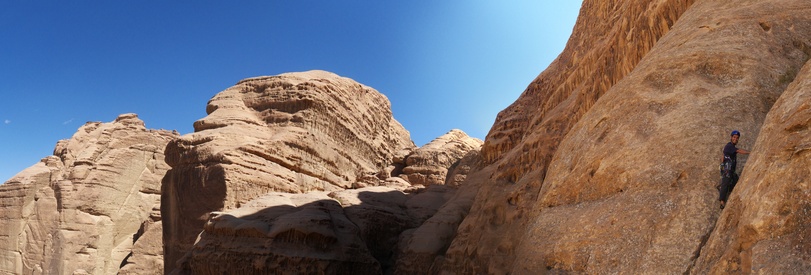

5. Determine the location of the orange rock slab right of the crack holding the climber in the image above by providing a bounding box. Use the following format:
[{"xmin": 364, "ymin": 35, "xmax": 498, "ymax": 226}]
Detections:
[{"xmin": 692, "ymin": 44, "xmax": 811, "ymax": 274}]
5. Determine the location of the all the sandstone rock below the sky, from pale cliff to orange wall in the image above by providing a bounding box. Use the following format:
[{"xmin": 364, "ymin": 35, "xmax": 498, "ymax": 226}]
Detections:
[{"xmin": 0, "ymin": 0, "xmax": 811, "ymax": 274}]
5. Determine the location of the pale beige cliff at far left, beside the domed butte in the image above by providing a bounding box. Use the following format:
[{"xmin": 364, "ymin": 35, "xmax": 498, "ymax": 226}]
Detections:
[{"xmin": 0, "ymin": 114, "xmax": 177, "ymax": 274}]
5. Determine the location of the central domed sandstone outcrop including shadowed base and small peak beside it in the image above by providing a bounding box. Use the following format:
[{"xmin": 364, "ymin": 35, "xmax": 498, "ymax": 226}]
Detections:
[{"xmin": 161, "ymin": 71, "xmax": 481, "ymax": 274}]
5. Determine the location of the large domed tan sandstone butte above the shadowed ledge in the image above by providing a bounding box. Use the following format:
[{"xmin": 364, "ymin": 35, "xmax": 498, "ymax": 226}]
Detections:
[{"xmin": 161, "ymin": 71, "xmax": 426, "ymax": 271}]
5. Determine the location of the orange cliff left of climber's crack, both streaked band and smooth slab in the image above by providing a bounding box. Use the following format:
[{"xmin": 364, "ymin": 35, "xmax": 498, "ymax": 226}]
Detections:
[{"xmin": 434, "ymin": 1, "xmax": 811, "ymax": 274}]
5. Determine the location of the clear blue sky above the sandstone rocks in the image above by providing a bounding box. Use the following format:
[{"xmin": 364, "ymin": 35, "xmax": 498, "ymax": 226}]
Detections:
[{"xmin": 0, "ymin": 0, "xmax": 581, "ymax": 182}]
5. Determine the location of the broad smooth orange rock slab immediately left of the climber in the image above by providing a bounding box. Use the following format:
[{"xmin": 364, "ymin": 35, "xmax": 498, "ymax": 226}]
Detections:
[{"xmin": 502, "ymin": 1, "xmax": 811, "ymax": 274}]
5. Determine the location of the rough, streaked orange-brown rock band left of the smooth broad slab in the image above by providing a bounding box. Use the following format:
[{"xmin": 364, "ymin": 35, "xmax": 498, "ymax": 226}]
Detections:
[{"xmin": 441, "ymin": 0, "xmax": 693, "ymax": 273}]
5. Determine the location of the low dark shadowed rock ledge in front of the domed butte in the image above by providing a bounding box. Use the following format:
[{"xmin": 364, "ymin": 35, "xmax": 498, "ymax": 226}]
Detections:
[{"xmin": 185, "ymin": 185, "xmax": 460, "ymax": 274}]
